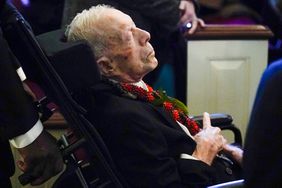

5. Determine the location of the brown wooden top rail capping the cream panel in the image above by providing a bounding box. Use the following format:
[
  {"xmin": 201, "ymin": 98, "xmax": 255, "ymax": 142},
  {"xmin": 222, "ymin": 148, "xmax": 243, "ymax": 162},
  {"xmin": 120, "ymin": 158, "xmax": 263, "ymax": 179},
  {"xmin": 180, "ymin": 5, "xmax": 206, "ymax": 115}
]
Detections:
[{"xmin": 184, "ymin": 24, "xmax": 273, "ymax": 40}]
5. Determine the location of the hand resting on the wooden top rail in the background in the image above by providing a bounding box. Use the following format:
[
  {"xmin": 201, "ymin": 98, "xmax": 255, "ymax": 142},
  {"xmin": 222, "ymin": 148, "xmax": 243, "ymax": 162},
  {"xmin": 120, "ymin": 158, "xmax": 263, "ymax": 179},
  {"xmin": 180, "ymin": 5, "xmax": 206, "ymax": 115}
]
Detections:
[{"xmin": 179, "ymin": 0, "xmax": 205, "ymax": 34}]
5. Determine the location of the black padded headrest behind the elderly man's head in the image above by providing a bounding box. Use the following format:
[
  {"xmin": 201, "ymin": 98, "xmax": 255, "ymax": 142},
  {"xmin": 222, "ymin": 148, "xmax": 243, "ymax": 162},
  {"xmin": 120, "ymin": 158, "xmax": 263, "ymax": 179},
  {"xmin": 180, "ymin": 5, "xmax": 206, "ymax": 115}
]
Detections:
[{"xmin": 36, "ymin": 29, "xmax": 100, "ymax": 92}]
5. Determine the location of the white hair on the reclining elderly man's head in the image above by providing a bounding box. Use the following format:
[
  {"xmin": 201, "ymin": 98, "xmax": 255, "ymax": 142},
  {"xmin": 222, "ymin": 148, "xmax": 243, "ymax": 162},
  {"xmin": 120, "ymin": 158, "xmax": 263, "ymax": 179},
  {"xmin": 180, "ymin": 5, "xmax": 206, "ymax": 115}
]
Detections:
[{"xmin": 65, "ymin": 5, "xmax": 114, "ymax": 59}]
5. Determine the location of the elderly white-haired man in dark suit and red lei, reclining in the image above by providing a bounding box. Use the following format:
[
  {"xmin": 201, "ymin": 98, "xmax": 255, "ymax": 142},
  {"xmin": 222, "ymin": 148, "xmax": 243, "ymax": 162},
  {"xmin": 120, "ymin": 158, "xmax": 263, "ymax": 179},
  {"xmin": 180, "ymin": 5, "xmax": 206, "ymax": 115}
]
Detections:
[{"xmin": 0, "ymin": 1, "xmax": 248, "ymax": 187}]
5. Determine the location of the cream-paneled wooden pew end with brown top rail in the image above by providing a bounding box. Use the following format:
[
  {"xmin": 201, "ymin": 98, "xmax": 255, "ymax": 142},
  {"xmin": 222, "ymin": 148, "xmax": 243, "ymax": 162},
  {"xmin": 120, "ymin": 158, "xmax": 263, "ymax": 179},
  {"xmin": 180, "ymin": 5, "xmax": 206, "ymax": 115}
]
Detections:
[{"xmin": 185, "ymin": 25, "xmax": 273, "ymax": 142}]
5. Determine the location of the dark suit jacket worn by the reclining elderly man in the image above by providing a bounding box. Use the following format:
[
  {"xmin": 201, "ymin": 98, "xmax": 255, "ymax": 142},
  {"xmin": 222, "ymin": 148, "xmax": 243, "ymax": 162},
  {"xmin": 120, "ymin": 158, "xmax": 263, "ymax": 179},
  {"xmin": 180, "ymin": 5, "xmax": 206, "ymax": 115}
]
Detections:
[{"xmin": 84, "ymin": 83, "xmax": 240, "ymax": 187}]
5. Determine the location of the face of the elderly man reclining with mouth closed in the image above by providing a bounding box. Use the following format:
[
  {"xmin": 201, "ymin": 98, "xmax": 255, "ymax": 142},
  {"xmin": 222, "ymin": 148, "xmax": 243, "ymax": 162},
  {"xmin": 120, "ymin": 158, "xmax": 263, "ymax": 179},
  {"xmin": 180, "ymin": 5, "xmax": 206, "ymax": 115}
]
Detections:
[{"xmin": 99, "ymin": 10, "xmax": 158, "ymax": 82}]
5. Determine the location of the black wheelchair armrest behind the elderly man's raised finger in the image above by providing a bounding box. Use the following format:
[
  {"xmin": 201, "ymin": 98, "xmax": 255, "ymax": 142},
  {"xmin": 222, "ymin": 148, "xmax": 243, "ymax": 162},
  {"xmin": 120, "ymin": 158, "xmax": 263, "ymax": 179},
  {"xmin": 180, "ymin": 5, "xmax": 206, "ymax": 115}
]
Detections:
[{"xmin": 190, "ymin": 113, "xmax": 242, "ymax": 146}]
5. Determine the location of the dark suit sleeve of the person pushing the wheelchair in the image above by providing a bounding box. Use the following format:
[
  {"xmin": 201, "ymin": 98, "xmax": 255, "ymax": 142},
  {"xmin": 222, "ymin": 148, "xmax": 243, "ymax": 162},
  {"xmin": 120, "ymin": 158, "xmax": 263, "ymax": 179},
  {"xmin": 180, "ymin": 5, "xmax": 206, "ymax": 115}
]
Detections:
[{"xmin": 0, "ymin": 28, "xmax": 38, "ymax": 181}]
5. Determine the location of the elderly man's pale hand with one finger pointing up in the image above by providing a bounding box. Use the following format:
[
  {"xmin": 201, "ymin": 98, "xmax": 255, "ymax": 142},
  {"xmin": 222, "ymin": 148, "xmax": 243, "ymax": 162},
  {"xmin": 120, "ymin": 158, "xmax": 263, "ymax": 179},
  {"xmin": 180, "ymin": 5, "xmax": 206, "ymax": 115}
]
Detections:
[{"xmin": 192, "ymin": 112, "xmax": 226, "ymax": 165}]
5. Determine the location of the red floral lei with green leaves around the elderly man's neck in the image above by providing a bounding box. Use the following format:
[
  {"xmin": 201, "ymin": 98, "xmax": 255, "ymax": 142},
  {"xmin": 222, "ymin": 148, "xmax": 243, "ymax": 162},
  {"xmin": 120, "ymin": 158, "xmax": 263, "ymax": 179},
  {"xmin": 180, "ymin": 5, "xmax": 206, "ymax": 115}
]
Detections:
[{"xmin": 120, "ymin": 83, "xmax": 200, "ymax": 135}]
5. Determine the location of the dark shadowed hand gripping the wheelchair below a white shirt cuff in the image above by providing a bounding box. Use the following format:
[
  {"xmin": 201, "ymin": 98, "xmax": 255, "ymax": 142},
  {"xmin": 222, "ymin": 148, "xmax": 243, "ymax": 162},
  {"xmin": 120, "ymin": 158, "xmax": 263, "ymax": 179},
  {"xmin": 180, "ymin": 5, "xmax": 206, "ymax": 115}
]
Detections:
[{"xmin": 17, "ymin": 130, "xmax": 63, "ymax": 185}]
